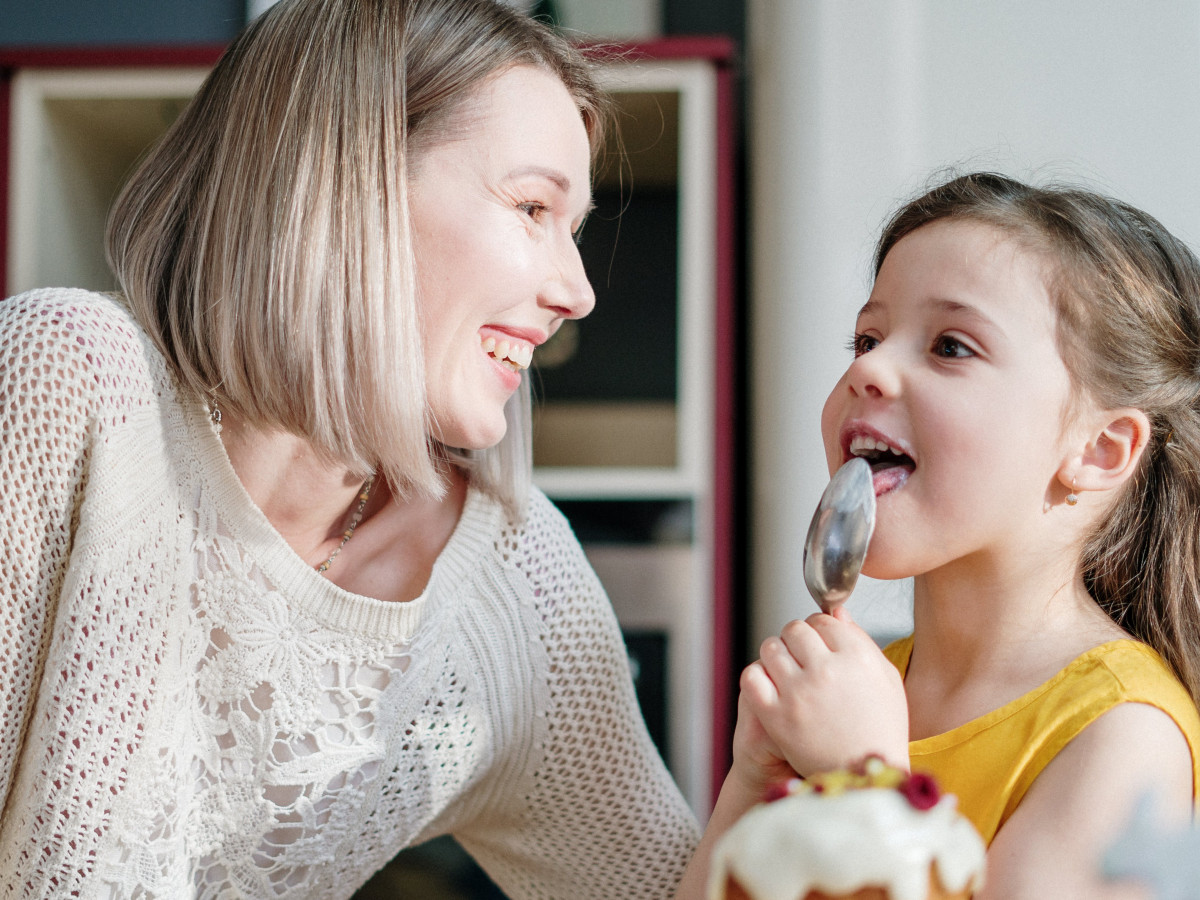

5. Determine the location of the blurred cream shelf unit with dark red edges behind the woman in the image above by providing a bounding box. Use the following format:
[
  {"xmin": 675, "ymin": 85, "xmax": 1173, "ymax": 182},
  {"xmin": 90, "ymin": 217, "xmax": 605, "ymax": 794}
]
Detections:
[{"xmin": 0, "ymin": 37, "xmax": 737, "ymax": 816}]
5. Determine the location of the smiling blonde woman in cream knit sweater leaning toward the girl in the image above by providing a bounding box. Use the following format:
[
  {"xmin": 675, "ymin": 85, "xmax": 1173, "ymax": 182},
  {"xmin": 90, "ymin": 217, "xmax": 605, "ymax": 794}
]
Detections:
[{"xmin": 0, "ymin": 0, "xmax": 698, "ymax": 898}]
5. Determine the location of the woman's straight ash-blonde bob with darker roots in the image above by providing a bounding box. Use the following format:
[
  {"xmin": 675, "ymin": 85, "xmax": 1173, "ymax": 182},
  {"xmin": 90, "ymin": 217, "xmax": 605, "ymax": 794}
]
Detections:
[{"xmin": 107, "ymin": 0, "xmax": 607, "ymax": 506}]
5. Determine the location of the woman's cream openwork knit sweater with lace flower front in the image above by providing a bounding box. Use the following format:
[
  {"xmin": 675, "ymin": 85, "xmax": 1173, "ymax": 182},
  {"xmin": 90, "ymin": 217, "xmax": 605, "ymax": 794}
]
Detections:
[{"xmin": 0, "ymin": 289, "xmax": 697, "ymax": 900}]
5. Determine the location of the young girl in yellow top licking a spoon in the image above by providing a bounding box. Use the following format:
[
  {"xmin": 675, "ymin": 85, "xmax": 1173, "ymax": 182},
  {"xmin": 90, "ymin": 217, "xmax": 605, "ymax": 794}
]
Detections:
[{"xmin": 743, "ymin": 174, "xmax": 1200, "ymax": 898}]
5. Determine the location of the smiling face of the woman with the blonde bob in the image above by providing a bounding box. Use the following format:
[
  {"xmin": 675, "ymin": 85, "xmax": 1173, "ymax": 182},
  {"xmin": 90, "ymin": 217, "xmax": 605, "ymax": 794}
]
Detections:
[{"xmin": 410, "ymin": 66, "xmax": 595, "ymax": 450}]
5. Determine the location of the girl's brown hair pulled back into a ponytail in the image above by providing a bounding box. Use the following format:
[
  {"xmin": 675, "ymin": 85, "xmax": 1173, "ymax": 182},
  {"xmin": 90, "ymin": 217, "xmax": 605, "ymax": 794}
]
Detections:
[{"xmin": 875, "ymin": 173, "xmax": 1200, "ymax": 703}]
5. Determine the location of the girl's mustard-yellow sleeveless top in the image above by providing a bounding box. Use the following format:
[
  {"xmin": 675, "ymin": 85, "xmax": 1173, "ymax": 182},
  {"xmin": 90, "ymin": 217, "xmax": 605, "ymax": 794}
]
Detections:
[{"xmin": 883, "ymin": 636, "xmax": 1200, "ymax": 844}]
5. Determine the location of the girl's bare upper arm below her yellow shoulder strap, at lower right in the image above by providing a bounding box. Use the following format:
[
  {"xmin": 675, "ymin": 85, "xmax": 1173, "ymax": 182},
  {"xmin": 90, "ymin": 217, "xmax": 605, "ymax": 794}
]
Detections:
[{"xmin": 977, "ymin": 703, "xmax": 1193, "ymax": 900}]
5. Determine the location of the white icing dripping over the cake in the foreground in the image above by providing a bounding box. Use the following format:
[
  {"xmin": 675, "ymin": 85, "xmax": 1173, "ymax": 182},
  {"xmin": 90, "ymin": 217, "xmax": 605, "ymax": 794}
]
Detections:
[{"xmin": 708, "ymin": 788, "xmax": 986, "ymax": 900}]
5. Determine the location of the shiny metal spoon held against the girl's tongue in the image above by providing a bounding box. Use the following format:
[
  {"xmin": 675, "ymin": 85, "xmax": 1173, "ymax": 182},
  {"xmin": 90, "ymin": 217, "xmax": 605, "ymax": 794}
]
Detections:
[{"xmin": 804, "ymin": 458, "xmax": 875, "ymax": 612}]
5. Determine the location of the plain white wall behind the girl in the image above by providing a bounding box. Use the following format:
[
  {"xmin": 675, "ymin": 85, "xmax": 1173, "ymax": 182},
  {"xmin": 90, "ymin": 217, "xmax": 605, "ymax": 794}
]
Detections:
[{"xmin": 746, "ymin": 0, "xmax": 1200, "ymax": 646}]
